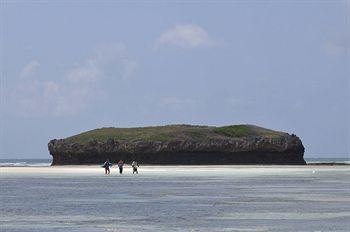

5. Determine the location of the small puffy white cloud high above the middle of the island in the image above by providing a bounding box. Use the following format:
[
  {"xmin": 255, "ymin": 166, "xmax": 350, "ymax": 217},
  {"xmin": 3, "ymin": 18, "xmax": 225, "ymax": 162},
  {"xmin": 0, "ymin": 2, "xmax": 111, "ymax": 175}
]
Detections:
[{"xmin": 155, "ymin": 24, "xmax": 217, "ymax": 48}]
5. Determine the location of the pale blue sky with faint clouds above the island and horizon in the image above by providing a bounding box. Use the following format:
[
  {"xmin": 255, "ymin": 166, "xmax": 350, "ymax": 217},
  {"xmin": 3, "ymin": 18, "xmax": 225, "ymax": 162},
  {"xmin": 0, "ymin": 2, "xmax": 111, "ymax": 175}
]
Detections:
[{"xmin": 0, "ymin": 0, "xmax": 350, "ymax": 158}]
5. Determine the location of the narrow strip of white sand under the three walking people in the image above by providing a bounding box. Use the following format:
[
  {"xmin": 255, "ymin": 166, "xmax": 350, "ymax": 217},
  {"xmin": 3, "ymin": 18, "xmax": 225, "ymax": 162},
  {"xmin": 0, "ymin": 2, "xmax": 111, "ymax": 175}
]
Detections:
[{"xmin": 0, "ymin": 165, "xmax": 350, "ymax": 177}]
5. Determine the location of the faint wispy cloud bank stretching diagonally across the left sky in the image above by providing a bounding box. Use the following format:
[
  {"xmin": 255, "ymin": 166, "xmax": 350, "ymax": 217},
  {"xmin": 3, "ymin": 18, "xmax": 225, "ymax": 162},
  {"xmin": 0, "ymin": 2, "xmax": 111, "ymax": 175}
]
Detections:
[{"xmin": 13, "ymin": 44, "xmax": 136, "ymax": 116}]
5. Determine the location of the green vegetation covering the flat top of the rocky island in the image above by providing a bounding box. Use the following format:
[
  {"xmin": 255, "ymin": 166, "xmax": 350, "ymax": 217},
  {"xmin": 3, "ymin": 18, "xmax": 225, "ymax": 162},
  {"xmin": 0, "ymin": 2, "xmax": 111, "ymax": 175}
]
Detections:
[{"xmin": 65, "ymin": 125, "xmax": 285, "ymax": 144}]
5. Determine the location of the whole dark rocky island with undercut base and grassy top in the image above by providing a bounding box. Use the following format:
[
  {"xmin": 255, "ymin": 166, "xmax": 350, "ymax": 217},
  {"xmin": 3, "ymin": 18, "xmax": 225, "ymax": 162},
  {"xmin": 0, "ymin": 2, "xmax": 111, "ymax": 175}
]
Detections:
[{"xmin": 48, "ymin": 125, "xmax": 306, "ymax": 165}]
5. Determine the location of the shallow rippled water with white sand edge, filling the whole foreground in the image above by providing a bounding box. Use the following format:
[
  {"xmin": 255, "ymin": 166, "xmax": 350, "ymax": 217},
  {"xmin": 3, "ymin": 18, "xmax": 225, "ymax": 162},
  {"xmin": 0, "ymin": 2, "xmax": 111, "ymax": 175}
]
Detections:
[{"xmin": 0, "ymin": 166, "xmax": 350, "ymax": 232}]
